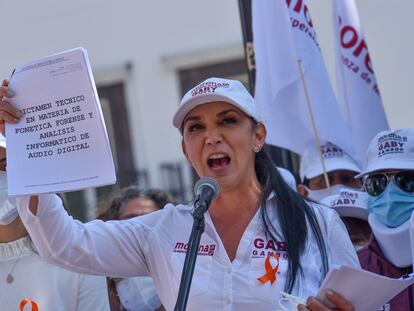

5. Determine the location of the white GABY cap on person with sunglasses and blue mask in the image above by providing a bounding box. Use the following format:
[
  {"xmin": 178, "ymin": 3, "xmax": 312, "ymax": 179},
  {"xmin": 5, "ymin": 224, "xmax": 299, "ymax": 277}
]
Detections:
[{"xmin": 356, "ymin": 129, "xmax": 414, "ymax": 178}]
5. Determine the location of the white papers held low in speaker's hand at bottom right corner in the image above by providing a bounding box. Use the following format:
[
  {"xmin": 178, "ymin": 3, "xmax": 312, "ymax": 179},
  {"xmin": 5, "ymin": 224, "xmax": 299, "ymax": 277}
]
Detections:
[{"xmin": 316, "ymin": 266, "xmax": 414, "ymax": 311}]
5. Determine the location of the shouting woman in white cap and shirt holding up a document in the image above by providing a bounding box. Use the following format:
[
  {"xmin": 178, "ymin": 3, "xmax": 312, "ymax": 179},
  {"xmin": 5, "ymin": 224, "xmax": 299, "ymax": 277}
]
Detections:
[{"xmin": 0, "ymin": 78, "xmax": 359, "ymax": 311}]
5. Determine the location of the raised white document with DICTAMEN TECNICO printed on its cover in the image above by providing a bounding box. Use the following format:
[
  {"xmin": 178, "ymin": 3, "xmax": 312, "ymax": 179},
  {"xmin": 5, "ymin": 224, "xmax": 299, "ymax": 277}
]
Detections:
[{"xmin": 6, "ymin": 48, "xmax": 116, "ymax": 195}]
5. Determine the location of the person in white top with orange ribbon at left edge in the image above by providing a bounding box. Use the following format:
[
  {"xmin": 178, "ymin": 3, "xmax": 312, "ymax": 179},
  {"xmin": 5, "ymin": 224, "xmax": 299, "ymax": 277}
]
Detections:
[{"xmin": 0, "ymin": 133, "xmax": 109, "ymax": 311}]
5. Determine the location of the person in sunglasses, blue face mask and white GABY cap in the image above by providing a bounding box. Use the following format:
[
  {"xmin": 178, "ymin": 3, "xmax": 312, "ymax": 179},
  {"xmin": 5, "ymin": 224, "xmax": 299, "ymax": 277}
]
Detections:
[{"xmin": 357, "ymin": 129, "xmax": 414, "ymax": 311}]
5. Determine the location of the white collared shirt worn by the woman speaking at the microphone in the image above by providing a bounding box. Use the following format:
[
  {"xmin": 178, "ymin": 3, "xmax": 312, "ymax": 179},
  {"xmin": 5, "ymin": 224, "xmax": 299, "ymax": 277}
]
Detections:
[{"xmin": 18, "ymin": 195, "xmax": 359, "ymax": 311}]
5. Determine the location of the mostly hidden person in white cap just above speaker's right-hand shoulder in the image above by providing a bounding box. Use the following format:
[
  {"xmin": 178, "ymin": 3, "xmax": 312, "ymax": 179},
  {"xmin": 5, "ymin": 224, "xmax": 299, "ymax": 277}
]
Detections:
[{"xmin": 321, "ymin": 188, "xmax": 372, "ymax": 251}]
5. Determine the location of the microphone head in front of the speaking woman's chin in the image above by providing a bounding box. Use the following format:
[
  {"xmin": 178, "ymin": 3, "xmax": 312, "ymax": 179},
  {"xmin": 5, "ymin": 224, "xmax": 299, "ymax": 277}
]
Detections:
[{"xmin": 193, "ymin": 177, "xmax": 220, "ymax": 215}]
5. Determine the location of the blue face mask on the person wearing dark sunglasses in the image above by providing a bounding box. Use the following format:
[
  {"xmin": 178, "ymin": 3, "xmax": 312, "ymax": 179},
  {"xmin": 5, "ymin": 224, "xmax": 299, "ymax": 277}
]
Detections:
[{"xmin": 368, "ymin": 181, "xmax": 414, "ymax": 228}]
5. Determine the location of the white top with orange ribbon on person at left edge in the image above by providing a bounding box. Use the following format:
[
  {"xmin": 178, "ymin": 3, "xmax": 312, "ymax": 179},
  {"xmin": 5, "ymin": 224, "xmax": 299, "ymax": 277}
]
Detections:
[{"xmin": 0, "ymin": 236, "xmax": 109, "ymax": 311}]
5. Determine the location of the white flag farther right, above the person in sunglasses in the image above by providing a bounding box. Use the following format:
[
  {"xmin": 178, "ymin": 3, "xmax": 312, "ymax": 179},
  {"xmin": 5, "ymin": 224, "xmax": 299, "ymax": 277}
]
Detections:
[{"xmin": 333, "ymin": 0, "xmax": 389, "ymax": 167}]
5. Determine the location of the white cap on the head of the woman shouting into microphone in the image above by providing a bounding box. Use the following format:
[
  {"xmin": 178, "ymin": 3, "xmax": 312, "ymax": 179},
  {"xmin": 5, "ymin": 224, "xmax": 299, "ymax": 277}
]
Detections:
[{"xmin": 173, "ymin": 78, "xmax": 262, "ymax": 129}]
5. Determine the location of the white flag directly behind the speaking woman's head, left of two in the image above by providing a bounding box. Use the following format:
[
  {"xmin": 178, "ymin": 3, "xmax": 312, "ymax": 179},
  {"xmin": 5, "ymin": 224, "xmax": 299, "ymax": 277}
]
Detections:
[{"xmin": 252, "ymin": 0, "xmax": 358, "ymax": 166}]
